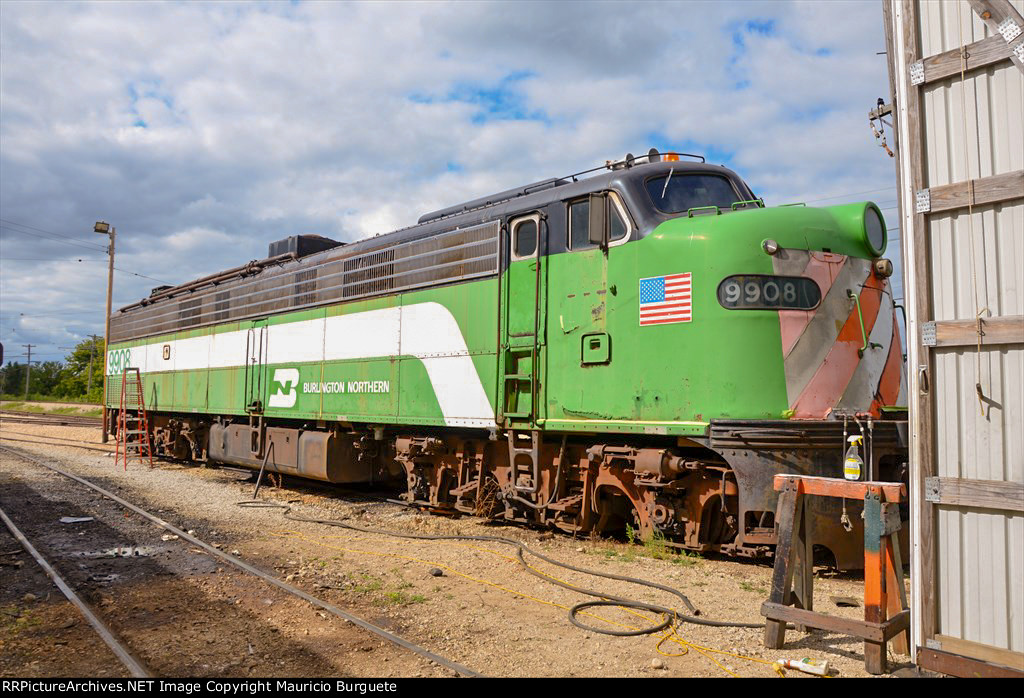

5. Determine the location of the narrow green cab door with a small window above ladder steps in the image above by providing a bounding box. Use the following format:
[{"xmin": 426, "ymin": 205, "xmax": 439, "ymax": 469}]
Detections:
[{"xmin": 499, "ymin": 212, "xmax": 547, "ymax": 429}]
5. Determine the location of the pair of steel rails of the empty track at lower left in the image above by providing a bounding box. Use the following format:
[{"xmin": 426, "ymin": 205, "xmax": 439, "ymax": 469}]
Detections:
[{"xmin": 0, "ymin": 445, "xmax": 480, "ymax": 677}]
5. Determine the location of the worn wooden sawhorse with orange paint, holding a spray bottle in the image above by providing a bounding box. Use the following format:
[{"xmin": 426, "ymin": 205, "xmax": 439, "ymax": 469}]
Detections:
[{"xmin": 761, "ymin": 475, "xmax": 910, "ymax": 674}]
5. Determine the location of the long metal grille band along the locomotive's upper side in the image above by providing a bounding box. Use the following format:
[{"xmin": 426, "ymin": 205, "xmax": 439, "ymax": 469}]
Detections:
[{"xmin": 111, "ymin": 215, "xmax": 501, "ymax": 343}]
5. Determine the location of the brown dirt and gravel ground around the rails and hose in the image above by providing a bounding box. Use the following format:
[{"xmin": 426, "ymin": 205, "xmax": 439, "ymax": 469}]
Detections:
[{"xmin": 0, "ymin": 424, "xmax": 909, "ymax": 678}]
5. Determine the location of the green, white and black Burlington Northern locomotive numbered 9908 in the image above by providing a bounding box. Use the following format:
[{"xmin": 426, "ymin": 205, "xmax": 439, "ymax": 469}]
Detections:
[{"xmin": 106, "ymin": 150, "xmax": 906, "ymax": 568}]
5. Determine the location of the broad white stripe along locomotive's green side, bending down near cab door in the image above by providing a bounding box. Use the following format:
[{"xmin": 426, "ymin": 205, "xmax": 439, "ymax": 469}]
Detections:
[{"xmin": 108, "ymin": 303, "xmax": 496, "ymax": 427}]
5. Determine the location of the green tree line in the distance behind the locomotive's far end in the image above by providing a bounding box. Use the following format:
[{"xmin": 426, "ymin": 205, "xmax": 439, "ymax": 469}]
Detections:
[{"xmin": 0, "ymin": 338, "xmax": 106, "ymax": 403}]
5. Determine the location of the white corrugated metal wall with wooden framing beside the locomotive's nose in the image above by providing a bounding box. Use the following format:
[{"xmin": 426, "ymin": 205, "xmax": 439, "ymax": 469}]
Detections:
[{"xmin": 884, "ymin": 0, "xmax": 1024, "ymax": 673}]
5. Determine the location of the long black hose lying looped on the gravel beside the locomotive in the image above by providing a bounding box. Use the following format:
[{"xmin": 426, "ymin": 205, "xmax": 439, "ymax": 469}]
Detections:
[{"xmin": 238, "ymin": 500, "xmax": 764, "ymax": 637}]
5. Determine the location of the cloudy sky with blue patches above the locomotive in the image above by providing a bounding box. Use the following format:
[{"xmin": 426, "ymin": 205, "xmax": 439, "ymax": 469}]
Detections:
[{"xmin": 0, "ymin": 0, "xmax": 902, "ymax": 361}]
